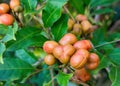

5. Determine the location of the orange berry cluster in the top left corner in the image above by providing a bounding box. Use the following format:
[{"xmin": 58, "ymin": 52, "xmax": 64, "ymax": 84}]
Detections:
[{"xmin": 0, "ymin": 0, "xmax": 22, "ymax": 26}]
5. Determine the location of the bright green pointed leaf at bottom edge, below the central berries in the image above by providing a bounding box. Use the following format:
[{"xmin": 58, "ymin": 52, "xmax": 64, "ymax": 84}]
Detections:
[{"xmin": 57, "ymin": 72, "xmax": 73, "ymax": 86}]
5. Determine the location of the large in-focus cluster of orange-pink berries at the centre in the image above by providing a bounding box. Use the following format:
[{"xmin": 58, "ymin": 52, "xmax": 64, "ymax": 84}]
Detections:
[{"xmin": 43, "ymin": 33, "xmax": 99, "ymax": 75}]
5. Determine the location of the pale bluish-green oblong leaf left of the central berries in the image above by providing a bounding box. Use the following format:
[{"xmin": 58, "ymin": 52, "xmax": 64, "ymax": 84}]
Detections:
[{"xmin": 15, "ymin": 49, "xmax": 37, "ymax": 65}]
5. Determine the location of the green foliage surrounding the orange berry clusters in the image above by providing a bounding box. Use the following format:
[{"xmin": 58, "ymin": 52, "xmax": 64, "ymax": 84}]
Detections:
[{"xmin": 0, "ymin": 0, "xmax": 120, "ymax": 86}]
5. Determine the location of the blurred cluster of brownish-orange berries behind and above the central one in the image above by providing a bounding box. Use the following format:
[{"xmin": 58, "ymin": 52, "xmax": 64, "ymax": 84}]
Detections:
[{"xmin": 68, "ymin": 14, "xmax": 94, "ymax": 35}]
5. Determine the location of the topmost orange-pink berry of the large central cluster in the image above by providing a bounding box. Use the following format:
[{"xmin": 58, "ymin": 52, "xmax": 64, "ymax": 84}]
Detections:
[{"xmin": 59, "ymin": 33, "xmax": 77, "ymax": 45}]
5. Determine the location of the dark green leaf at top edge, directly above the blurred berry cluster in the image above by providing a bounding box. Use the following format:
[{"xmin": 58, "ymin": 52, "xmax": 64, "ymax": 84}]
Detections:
[{"xmin": 69, "ymin": 0, "xmax": 86, "ymax": 14}]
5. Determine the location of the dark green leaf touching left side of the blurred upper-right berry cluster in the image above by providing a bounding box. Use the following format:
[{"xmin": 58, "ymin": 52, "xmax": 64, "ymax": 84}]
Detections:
[{"xmin": 51, "ymin": 15, "xmax": 68, "ymax": 41}]
